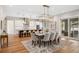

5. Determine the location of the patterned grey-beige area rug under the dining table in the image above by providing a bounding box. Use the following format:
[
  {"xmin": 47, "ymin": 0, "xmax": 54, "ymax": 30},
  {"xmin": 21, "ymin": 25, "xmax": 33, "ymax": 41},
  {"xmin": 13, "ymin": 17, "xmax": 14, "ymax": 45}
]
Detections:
[{"xmin": 21, "ymin": 39, "xmax": 59, "ymax": 53}]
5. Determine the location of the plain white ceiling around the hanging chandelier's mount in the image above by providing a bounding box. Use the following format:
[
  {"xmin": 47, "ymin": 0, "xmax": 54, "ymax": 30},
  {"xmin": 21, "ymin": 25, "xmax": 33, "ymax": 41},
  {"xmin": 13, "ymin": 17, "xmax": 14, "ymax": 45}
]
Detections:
[{"xmin": 4, "ymin": 5, "xmax": 79, "ymax": 17}]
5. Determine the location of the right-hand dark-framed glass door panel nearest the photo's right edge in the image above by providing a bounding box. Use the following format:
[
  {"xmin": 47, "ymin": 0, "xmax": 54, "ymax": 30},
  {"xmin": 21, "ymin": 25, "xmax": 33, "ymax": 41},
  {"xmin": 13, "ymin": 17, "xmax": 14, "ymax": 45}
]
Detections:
[{"xmin": 69, "ymin": 18, "xmax": 78, "ymax": 38}]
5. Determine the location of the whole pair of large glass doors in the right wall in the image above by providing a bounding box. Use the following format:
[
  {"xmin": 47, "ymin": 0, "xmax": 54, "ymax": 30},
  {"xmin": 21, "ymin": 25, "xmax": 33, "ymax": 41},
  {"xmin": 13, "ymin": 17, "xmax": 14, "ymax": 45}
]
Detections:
[{"xmin": 61, "ymin": 18, "xmax": 79, "ymax": 38}]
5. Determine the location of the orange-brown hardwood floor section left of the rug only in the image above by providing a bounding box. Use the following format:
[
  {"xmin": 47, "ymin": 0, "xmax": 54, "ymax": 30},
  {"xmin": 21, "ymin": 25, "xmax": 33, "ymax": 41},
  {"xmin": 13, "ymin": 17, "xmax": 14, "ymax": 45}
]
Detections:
[{"xmin": 0, "ymin": 36, "xmax": 30, "ymax": 53}]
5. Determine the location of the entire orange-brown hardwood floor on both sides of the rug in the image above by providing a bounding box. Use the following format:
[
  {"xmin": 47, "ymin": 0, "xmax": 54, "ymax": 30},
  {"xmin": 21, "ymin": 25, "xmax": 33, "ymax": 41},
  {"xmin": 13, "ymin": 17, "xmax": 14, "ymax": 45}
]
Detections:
[{"xmin": 0, "ymin": 36, "xmax": 79, "ymax": 53}]
